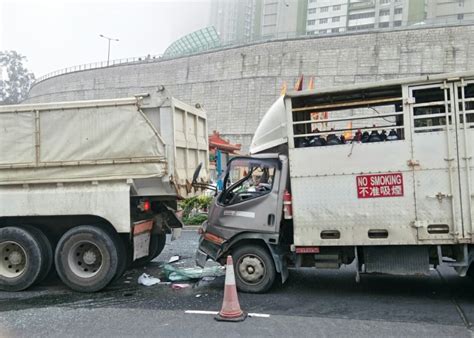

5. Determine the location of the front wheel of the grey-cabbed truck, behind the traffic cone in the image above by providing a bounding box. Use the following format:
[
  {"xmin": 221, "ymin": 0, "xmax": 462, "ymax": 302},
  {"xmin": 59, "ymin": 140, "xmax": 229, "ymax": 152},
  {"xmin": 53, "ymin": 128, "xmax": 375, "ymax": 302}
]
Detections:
[{"xmin": 232, "ymin": 245, "xmax": 276, "ymax": 293}]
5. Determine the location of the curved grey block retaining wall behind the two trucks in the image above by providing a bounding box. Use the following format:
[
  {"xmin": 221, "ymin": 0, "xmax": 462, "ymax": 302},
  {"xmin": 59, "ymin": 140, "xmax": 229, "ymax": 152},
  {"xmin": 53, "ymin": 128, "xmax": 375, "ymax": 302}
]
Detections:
[{"xmin": 28, "ymin": 25, "xmax": 474, "ymax": 150}]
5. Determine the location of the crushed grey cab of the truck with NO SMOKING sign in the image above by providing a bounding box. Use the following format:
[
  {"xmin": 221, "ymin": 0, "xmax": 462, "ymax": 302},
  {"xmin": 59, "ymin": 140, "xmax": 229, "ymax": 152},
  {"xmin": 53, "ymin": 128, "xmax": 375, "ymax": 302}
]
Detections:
[{"xmin": 197, "ymin": 154, "xmax": 288, "ymax": 292}]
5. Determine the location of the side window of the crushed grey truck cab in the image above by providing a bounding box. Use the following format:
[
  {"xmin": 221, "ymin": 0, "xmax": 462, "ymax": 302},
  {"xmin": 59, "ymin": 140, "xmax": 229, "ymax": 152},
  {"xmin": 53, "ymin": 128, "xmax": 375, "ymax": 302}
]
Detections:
[{"xmin": 218, "ymin": 158, "xmax": 276, "ymax": 205}]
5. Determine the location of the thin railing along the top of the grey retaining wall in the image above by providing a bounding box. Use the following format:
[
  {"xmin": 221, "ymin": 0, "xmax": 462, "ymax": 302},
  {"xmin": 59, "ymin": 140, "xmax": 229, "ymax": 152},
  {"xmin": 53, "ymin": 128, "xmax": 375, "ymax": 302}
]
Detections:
[{"xmin": 32, "ymin": 20, "xmax": 474, "ymax": 86}]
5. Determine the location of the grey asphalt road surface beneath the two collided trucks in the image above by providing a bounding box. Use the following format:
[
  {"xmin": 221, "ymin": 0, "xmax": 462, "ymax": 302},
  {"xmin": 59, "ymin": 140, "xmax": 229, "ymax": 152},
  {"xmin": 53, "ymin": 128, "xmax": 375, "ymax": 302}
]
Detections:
[{"xmin": 0, "ymin": 230, "xmax": 474, "ymax": 337}]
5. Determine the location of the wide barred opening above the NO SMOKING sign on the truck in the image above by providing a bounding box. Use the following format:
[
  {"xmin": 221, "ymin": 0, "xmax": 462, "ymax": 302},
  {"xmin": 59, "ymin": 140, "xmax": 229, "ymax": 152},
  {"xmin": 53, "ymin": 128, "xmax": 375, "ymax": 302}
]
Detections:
[{"xmin": 292, "ymin": 86, "xmax": 405, "ymax": 148}]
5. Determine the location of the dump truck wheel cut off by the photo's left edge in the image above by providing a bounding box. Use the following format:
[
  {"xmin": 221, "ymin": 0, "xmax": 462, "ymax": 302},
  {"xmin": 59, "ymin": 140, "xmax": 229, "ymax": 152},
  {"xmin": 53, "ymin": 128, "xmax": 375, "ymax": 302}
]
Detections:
[{"xmin": 0, "ymin": 227, "xmax": 44, "ymax": 291}]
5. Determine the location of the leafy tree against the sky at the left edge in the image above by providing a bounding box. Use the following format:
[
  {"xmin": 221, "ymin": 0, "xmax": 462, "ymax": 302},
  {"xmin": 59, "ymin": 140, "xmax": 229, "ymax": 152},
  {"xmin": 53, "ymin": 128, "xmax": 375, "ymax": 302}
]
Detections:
[{"xmin": 0, "ymin": 50, "xmax": 35, "ymax": 104}]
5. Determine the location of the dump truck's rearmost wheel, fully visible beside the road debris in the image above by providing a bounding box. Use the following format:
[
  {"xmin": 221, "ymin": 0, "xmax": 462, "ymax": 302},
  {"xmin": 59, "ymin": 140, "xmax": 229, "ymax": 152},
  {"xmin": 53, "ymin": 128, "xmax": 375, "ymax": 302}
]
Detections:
[{"xmin": 54, "ymin": 225, "xmax": 119, "ymax": 292}]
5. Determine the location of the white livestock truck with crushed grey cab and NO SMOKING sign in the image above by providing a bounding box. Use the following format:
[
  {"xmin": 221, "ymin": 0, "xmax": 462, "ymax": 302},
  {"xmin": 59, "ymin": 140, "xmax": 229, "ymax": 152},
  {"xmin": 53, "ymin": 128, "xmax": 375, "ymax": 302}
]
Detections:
[{"xmin": 197, "ymin": 73, "xmax": 474, "ymax": 292}]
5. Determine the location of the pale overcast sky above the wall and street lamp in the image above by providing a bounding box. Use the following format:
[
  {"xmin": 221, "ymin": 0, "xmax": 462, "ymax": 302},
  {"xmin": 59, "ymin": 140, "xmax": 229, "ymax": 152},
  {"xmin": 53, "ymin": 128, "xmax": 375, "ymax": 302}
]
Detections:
[{"xmin": 0, "ymin": 0, "xmax": 210, "ymax": 77}]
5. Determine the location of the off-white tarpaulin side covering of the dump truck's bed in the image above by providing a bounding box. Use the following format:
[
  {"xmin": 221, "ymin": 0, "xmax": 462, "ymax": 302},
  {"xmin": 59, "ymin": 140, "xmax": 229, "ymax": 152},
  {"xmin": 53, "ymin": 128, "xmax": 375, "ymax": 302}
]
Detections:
[{"xmin": 0, "ymin": 99, "xmax": 165, "ymax": 184}]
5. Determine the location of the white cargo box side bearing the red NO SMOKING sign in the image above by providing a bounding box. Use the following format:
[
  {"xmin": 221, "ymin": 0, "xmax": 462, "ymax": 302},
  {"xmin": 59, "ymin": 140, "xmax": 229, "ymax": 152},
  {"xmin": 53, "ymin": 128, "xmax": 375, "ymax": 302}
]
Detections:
[{"xmin": 285, "ymin": 74, "xmax": 474, "ymax": 246}]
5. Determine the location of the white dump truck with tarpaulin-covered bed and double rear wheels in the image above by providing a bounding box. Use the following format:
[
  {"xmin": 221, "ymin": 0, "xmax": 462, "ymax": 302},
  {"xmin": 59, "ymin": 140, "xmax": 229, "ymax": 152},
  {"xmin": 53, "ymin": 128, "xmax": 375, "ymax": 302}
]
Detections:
[{"xmin": 0, "ymin": 86, "xmax": 208, "ymax": 292}]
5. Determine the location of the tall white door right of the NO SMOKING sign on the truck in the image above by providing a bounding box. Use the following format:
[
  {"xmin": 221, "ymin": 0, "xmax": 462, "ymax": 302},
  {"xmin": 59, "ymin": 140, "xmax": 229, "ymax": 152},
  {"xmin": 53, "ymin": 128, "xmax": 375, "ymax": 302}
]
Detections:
[{"xmin": 408, "ymin": 81, "xmax": 470, "ymax": 242}]
